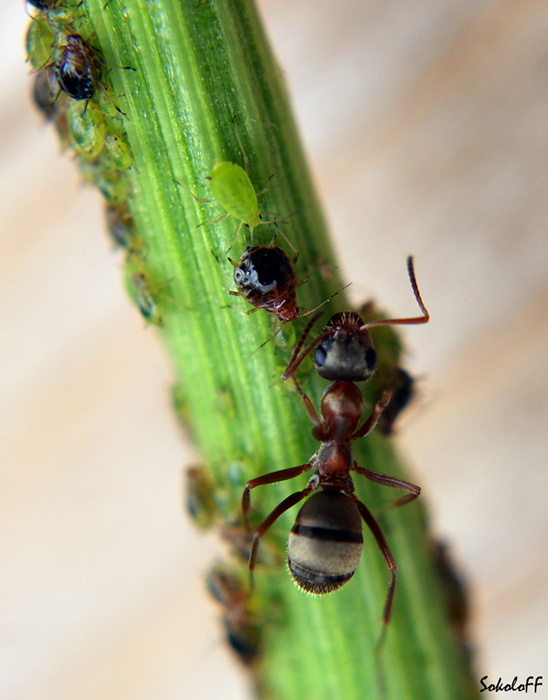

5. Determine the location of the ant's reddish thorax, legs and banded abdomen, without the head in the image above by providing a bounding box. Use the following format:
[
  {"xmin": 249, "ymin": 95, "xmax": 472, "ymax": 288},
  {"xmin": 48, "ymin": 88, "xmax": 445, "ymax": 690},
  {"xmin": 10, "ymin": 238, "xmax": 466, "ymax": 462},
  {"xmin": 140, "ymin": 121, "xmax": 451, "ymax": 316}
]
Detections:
[{"xmin": 242, "ymin": 381, "xmax": 420, "ymax": 625}]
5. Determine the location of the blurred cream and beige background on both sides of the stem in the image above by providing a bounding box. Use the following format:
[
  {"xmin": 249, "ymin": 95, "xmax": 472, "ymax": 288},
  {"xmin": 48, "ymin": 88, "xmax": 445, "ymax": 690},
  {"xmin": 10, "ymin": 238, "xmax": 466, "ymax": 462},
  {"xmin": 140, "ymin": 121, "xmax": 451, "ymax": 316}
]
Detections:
[{"xmin": 0, "ymin": 0, "xmax": 548, "ymax": 700}]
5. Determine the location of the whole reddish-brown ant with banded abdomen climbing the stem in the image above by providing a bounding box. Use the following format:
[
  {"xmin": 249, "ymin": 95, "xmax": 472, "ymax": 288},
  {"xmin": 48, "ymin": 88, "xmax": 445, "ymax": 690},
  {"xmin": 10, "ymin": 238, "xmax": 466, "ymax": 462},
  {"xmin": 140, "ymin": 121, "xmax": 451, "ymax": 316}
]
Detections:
[{"xmin": 242, "ymin": 258, "xmax": 429, "ymax": 639}]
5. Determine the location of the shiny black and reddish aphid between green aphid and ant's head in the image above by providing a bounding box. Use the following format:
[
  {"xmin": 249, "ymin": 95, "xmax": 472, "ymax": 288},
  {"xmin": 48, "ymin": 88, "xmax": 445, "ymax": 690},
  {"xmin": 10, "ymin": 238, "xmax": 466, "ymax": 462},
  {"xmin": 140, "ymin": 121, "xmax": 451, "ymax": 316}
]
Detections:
[{"xmin": 229, "ymin": 245, "xmax": 298, "ymax": 323}]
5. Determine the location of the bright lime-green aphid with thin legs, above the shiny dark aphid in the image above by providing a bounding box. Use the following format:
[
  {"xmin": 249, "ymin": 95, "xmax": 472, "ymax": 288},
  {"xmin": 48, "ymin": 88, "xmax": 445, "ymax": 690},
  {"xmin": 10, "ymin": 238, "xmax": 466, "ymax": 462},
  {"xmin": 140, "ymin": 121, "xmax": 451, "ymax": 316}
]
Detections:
[{"xmin": 181, "ymin": 119, "xmax": 295, "ymax": 253}]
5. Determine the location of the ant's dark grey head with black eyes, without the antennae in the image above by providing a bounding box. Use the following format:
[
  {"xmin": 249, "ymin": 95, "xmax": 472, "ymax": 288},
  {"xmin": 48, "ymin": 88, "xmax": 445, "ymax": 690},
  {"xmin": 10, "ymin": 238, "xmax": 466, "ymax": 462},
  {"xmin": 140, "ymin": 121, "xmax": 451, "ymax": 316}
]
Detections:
[{"xmin": 314, "ymin": 311, "xmax": 377, "ymax": 382}]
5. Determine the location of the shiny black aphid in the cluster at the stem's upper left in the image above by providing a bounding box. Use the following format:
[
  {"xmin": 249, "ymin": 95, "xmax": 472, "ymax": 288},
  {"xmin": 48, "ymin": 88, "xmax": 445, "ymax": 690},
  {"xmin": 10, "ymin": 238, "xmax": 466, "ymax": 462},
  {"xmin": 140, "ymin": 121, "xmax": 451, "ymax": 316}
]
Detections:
[{"xmin": 55, "ymin": 34, "xmax": 100, "ymax": 100}]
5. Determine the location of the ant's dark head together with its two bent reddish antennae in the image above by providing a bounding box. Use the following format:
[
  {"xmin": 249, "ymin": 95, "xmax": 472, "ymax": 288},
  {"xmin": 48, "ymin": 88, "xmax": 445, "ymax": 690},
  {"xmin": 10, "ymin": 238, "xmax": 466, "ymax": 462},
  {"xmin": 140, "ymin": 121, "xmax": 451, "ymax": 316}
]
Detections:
[{"xmin": 282, "ymin": 256, "xmax": 430, "ymax": 382}]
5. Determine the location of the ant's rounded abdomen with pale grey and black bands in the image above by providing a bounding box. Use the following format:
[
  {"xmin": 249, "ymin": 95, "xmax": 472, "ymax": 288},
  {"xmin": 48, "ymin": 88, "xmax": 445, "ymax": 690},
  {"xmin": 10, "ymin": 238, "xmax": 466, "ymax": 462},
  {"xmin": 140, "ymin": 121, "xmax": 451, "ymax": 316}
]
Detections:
[{"xmin": 287, "ymin": 491, "xmax": 363, "ymax": 595}]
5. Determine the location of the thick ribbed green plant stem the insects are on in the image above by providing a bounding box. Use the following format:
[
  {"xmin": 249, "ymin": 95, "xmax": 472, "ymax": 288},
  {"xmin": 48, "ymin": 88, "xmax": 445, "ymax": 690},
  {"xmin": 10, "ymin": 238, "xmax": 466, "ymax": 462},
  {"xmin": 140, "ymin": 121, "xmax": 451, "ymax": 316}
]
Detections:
[{"xmin": 30, "ymin": 0, "xmax": 476, "ymax": 700}]
